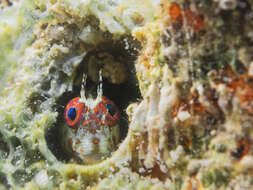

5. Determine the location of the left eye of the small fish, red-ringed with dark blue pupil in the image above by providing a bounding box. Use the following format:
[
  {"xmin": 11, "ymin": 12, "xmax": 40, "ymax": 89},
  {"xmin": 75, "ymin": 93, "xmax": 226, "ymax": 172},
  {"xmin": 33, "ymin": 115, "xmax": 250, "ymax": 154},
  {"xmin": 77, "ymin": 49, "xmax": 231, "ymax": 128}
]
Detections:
[{"xmin": 64, "ymin": 97, "xmax": 85, "ymax": 127}]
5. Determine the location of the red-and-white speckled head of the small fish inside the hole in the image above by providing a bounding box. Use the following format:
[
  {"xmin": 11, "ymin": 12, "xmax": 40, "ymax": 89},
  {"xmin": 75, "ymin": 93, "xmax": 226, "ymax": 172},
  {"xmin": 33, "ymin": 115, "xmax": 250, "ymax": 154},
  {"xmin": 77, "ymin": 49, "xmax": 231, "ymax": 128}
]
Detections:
[{"xmin": 64, "ymin": 96, "xmax": 119, "ymax": 164}]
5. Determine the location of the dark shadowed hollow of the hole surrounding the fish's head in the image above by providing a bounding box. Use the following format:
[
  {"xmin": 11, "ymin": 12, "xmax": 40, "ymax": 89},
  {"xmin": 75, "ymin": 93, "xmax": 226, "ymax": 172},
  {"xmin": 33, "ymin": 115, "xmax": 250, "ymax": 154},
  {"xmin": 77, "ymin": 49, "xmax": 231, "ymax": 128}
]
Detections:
[{"xmin": 46, "ymin": 37, "xmax": 141, "ymax": 162}]
